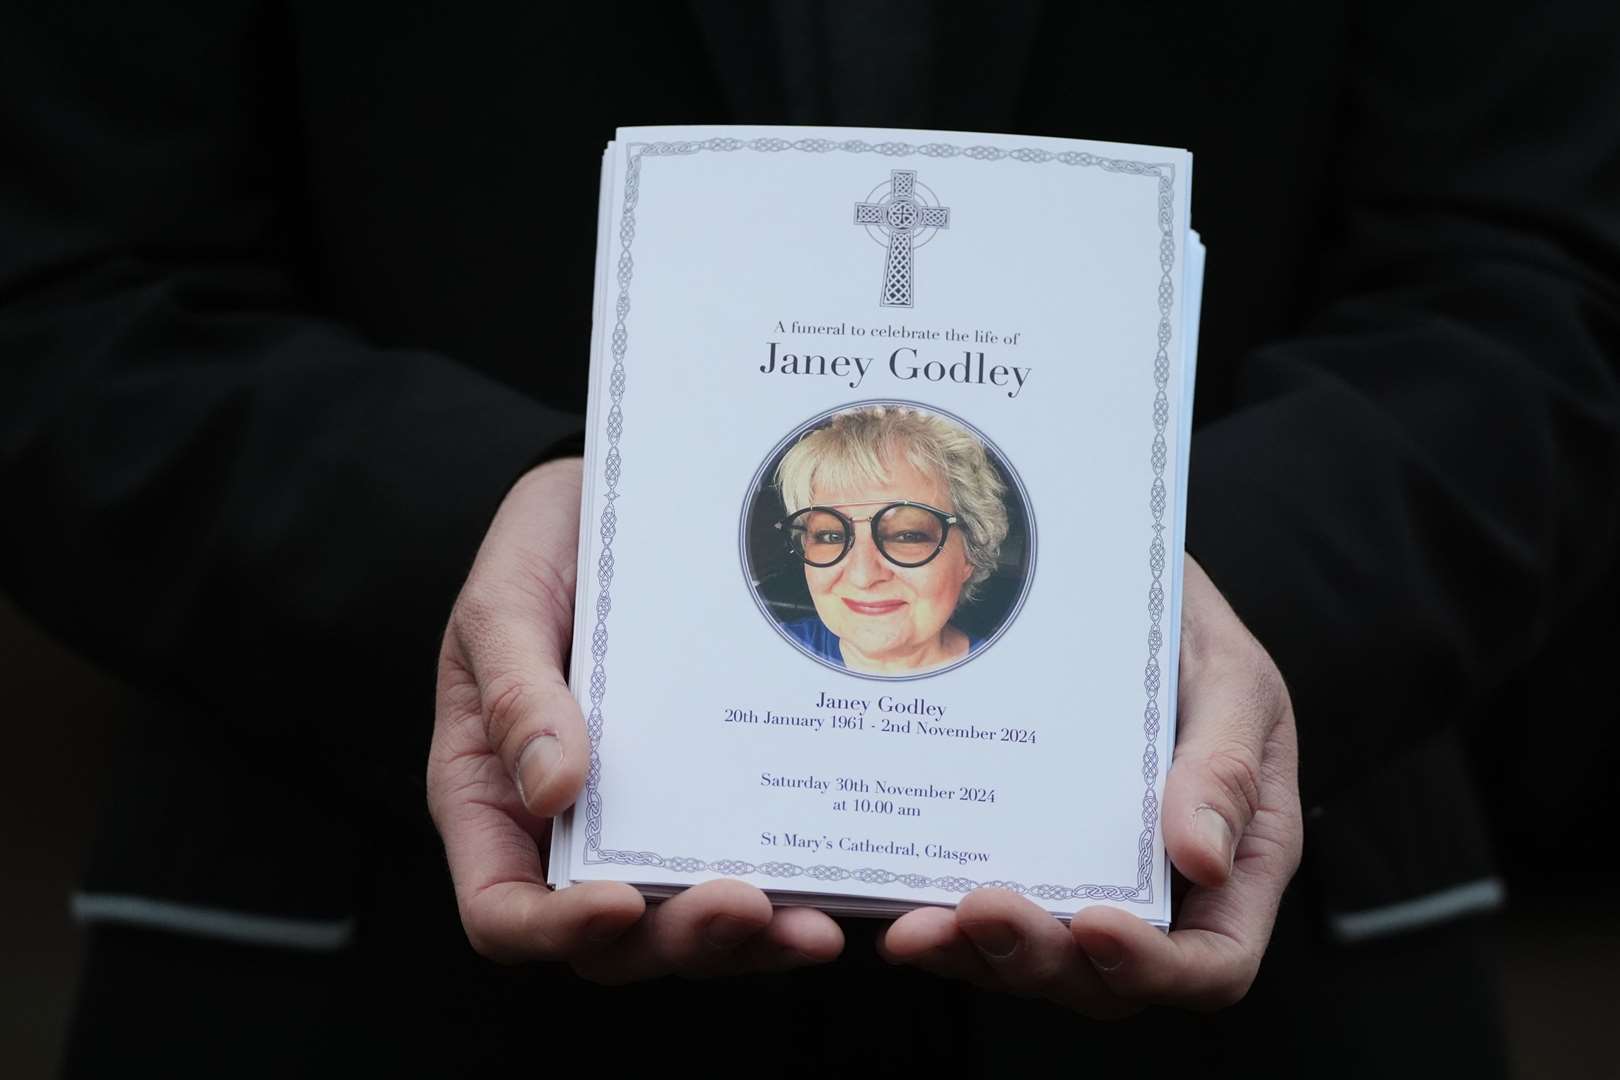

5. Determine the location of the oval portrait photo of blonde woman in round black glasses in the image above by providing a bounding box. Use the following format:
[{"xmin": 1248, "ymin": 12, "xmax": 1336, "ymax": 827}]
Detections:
[{"xmin": 742, "ymin": 402, "xmax": 1035, "ymax": 678}]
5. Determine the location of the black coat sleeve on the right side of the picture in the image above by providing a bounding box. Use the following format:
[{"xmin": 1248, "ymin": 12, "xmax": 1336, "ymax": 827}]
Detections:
[{"xmin": 1187, "ymin": 3, "xmax": 1620, "ymax": 800}]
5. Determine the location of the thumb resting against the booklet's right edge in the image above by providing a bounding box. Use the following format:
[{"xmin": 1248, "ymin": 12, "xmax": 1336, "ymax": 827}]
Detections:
[{"xmin": 1162, "ymin": 559, "xmax": 1288, "ymax": 886}]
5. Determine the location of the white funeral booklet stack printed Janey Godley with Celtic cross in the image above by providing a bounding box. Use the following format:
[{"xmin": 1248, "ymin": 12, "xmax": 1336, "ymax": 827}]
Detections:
[{"xmin": 549, "ymin": 126, "xmax": 1202, "ymax": 925}]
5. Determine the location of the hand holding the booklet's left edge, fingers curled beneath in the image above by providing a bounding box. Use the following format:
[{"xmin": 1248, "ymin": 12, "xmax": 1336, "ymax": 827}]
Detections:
[{"xmin": 428, "ymin": 458, "xmax": 844, "ymax": 983}]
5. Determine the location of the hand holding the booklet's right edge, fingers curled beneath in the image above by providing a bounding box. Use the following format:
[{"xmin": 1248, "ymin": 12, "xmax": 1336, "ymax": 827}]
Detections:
[{"xmin": 880, "ymin": 559, "xmax": 1304, "ymax": 1018}]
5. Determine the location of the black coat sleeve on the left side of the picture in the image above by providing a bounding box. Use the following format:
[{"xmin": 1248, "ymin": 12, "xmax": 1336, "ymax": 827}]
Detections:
[{"xmin": 0, "ymin": 0, "xmax": 578, "ymax": 818}]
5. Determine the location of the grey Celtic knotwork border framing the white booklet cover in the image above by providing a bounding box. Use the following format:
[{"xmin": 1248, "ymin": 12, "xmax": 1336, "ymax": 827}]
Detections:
[{"xmin": 585, "ymin": 136, "xmax": 1176, "ymax": 904}]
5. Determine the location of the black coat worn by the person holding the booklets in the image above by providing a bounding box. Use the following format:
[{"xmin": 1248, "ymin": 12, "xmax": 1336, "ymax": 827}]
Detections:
[{"xmin": 0, "ymin": 0, "xmax": 1620, "ymax": 1062}]
